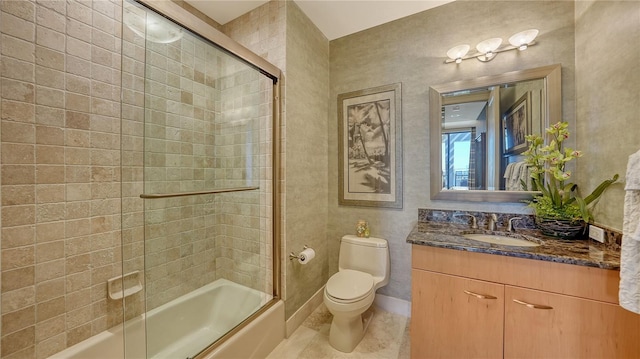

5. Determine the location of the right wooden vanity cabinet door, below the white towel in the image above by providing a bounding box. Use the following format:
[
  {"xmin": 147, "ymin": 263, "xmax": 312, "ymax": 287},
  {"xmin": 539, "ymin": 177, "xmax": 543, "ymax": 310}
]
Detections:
[{"xmin": 504, "ymin": 286, "xmax": 640, "ymax": 359}]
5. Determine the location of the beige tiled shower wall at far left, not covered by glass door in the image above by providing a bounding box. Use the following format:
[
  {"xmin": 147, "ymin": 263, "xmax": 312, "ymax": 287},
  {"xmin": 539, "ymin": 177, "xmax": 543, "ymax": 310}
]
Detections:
[{"xmin": 0, "ymin": 0, "xmax": 122, "ymax": 359}]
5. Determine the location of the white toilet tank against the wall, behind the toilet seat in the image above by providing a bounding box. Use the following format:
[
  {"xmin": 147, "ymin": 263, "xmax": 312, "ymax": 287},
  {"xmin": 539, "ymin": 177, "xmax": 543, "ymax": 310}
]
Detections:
[{"xmin": 338, "ymin": 235, "xmax": 390, "ymax": 289}]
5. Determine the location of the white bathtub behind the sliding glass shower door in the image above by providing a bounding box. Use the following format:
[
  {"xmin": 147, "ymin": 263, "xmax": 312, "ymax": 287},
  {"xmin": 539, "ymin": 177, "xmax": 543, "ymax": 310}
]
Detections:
[{"xmin": 49, "ymin": 279, "xmax": 285, "ymax": 359}]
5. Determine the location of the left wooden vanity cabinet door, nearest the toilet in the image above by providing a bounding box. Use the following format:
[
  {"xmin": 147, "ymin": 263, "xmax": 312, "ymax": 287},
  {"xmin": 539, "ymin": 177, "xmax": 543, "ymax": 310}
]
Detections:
[{"xmin": 411, "ymin": 269, "xmax": 504, "ymax": 359}]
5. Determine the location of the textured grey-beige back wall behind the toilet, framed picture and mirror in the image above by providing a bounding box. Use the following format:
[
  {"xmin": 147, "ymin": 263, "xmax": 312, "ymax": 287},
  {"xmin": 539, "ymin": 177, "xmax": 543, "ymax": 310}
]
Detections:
[{"xmin": 327, "ymin": 1, "xmax": 575, "ymax": 300}]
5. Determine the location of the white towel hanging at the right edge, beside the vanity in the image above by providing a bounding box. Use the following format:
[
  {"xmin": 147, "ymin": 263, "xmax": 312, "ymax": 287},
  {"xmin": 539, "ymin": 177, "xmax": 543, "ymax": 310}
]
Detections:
[{"xmin": 618, "ymin": 151, "xmax": 640, "ymax": 314}]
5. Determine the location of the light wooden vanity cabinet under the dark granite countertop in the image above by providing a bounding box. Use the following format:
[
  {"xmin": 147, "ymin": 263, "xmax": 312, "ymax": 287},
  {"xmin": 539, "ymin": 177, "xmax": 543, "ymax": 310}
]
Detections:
[{"xmin": 410, "ymin": 245, "xmax": 640, "ymax": 359}]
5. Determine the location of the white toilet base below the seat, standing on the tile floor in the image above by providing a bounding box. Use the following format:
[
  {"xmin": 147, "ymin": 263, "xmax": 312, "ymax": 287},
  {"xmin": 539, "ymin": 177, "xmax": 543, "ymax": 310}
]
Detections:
[{"xmin": 329, "ymin": 308, "xmax": 373, "ymax": 353}]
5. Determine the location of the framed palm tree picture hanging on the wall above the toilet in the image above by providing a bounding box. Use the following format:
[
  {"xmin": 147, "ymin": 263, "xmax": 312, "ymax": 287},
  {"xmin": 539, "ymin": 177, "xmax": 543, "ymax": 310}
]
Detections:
[{"xmin": 338, "ymin": 83, "xmax": 402, "ymax": 208}]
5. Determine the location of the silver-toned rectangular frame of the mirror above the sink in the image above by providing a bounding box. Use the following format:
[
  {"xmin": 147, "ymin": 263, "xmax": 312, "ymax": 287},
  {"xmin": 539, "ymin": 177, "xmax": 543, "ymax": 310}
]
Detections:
[{"xmin": 429, "ymin": 64, "xmax": 562, "ymax": 202}]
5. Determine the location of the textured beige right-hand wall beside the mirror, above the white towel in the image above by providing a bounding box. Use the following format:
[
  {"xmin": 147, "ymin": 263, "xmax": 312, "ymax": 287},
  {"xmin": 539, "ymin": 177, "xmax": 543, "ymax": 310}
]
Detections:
[{"xmin": 576, "ymin": 1, "xmax": 640, "ymax": 230}]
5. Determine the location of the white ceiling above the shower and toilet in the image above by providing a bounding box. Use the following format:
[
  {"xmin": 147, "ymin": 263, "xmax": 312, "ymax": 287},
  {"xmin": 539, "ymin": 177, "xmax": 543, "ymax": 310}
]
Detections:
[{"xmin": 185, "ymin": 0, "xmax": 453, "ymax": 40}]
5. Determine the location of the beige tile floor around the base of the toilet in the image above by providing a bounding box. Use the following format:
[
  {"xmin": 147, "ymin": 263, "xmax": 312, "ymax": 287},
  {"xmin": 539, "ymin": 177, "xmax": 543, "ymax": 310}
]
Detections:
[{"xmin": 267, "ymin": 304, "xmax": 409, "ymax": 359}]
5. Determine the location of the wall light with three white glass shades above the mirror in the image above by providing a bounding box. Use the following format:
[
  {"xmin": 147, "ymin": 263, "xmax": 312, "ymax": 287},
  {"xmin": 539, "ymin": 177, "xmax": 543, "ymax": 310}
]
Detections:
[{"xmin": 445, "ymin": 29, "xmax": 538, "ymax": 64}]
